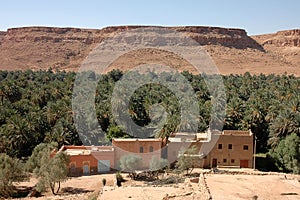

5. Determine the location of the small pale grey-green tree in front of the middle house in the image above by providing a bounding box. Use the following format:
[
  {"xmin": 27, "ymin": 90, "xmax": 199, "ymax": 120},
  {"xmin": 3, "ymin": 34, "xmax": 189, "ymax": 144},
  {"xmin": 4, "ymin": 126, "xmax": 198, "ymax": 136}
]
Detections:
[{"xmin": 120, "ymin": 154, "xmax": 142, "ymax": 178}]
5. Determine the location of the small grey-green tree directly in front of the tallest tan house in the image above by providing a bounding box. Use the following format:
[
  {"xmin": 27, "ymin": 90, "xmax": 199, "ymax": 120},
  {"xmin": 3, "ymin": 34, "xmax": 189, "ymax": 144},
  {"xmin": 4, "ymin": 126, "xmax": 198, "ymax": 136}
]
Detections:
[{"xmin": 175, "ymin": 146, "xmax": 199, "ymax": 174}]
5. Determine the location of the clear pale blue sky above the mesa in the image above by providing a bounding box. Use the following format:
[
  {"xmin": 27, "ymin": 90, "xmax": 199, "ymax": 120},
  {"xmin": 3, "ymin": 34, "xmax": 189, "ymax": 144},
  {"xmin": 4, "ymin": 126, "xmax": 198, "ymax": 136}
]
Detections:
[{"xmin": 0, "ymin": 0, "xmax": 300, "ymax": 35}]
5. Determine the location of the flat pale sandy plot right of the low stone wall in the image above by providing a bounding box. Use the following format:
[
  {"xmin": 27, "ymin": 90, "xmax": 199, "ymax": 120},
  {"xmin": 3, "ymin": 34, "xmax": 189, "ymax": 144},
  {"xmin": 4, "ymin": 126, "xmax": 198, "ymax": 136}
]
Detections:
[{"xmin": 205, "ymin": 174, "xmax": 300, "ymax": 200}]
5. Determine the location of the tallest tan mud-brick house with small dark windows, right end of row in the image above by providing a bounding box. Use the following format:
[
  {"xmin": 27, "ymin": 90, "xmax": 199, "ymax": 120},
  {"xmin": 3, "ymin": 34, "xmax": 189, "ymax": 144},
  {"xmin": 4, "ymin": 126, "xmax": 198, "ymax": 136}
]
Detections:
[{"xmin": 167, "ymin": 130, "xmax": 254, "ymax": 168}]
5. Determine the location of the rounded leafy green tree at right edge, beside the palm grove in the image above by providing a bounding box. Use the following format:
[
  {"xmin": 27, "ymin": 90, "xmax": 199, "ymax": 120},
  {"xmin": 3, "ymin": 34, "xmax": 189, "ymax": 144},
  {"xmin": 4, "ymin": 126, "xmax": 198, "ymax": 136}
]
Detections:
[{"xmin": 271, "ymin": 133, "xmax": 300, "ymax": 174}]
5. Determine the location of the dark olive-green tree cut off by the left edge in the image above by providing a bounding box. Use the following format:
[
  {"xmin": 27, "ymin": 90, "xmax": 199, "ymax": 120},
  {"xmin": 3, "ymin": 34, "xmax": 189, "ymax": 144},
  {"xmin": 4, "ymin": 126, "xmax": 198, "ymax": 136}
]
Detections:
[{"xmin": 0, "ymin": 154, "xmax": 28, "ymax": 197}]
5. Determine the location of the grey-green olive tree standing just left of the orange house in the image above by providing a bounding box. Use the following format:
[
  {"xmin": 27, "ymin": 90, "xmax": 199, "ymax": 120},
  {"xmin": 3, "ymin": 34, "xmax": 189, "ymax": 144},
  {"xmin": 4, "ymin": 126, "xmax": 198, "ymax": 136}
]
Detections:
[{"xmin": 28, "ymin": 143, "xmax": 69, "ymax": 195}]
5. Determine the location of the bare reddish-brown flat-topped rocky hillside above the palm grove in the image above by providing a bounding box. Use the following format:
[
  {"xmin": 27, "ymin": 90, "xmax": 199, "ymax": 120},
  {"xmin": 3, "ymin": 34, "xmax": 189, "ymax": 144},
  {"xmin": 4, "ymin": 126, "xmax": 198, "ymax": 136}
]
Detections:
[{"xmin": 0, "ymin": 26, "xmax": 300, "ymax": 76}]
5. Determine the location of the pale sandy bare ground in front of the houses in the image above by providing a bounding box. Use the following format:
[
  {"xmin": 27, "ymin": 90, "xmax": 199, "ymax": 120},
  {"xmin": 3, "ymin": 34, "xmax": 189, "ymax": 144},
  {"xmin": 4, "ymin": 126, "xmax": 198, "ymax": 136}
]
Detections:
[{"xmin": 20, "ymin": 169, "xmax": 300, "ymax": 200}]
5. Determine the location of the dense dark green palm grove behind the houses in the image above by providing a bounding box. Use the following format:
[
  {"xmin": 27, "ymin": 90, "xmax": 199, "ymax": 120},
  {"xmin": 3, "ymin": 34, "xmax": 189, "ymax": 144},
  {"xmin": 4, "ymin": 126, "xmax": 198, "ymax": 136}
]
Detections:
[{"xmin": 0, "ymin": 70, "xmax": 300, "ymax": 173}]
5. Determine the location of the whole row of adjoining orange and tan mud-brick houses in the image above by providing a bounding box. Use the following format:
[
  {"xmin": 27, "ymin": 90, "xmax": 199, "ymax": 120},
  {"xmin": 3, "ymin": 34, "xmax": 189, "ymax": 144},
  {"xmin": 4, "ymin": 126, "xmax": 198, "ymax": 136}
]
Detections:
[{"xmin": 60, "ymin": 130, "xmax": 254, "ymax": 176}]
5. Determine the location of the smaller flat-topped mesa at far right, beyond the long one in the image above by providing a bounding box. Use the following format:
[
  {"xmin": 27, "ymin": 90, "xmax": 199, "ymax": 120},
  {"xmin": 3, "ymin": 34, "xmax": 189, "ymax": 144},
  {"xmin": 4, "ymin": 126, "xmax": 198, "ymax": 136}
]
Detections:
[{"xmin": 263, "ymin": 29, "xmax": 300, "ymax": 47}]
